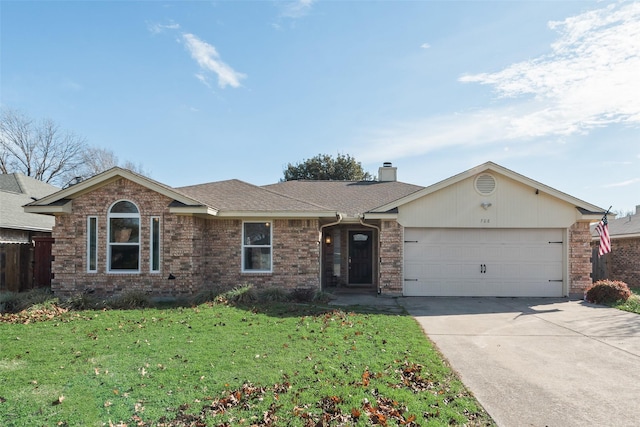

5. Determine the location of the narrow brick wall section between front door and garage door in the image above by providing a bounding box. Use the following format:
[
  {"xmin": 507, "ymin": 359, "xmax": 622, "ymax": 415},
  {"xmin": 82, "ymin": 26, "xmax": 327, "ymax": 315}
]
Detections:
[{"xmin": 379, "ymin": 221, "xmax": 404, "ymax": 295}]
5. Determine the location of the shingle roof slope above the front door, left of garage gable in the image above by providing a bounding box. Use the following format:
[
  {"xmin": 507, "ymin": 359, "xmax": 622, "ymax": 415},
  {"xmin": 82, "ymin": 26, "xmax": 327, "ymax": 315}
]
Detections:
[{"xmin": 262, "ymin": 180, "xmax": 424, "ymax": 215}]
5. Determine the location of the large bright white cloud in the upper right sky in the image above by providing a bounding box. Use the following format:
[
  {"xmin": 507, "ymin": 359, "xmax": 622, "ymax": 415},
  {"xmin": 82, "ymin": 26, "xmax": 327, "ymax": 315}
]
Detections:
[{"xmin": 460, "ymin": 3, "xmax": 640, "ymax": 130}]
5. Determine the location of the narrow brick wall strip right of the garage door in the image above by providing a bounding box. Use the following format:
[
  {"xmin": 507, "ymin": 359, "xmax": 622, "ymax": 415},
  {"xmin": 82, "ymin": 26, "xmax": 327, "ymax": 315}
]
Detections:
[{"xmin": 569, "ymin": 222, "xmax": 592, "ymax": 296}]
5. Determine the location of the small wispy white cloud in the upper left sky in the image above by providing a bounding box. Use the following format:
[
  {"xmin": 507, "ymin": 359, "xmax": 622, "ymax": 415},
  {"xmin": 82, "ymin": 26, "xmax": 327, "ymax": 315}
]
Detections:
[{"xmin": 182, "ymin": 34, "xmax": 246, "ymax": 88}]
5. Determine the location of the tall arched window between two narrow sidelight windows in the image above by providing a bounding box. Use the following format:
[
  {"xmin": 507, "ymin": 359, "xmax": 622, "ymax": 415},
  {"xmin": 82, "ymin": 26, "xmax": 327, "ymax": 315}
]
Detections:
[{"xmin": 107, "ymin": 200, "xmax": 140, "ymax": 273}]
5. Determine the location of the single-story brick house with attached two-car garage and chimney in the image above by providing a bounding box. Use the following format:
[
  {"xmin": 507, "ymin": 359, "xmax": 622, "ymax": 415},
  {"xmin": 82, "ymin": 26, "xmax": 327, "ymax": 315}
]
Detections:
[{"xmin": 25, "ymin": 162, "xmax": 604, "ymax": 297}]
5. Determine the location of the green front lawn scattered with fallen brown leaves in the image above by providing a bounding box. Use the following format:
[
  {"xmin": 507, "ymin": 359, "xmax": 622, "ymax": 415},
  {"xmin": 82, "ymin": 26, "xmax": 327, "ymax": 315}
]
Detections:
[{"xmin": 0, "ymin": 304, "xmax": 493, "ymax": 426}]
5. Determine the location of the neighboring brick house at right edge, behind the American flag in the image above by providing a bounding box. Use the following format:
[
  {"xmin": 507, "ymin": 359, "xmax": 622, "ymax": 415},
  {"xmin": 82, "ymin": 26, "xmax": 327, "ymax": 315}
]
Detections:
[{"xmin": 591, "ymin": 205, "xmax": 640, "ymax": 288}]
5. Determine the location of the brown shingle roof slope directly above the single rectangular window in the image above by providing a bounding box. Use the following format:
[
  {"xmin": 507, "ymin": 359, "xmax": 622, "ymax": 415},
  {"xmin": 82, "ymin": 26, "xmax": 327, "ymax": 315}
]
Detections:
[{"xmin": 176, "ymin": 179, "xmax": 326, "ymax": 212}]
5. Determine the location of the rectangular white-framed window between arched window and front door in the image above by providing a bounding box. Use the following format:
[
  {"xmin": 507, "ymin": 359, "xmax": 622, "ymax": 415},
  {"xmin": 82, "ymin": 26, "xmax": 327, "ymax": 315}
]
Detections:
[{"xmin": 242, "ymin": 221, "xmax": 271, "ymax": 273}]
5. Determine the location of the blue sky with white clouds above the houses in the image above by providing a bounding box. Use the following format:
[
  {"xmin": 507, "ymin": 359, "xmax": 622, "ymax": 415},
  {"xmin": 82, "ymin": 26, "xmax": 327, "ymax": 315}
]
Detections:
[{"xmin": 0, "ymin": 0, "xmax": 640, "ymax": 211}]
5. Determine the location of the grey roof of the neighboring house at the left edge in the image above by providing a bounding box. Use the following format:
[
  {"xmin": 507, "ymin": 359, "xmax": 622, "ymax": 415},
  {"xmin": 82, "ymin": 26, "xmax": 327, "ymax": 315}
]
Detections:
[{"xmin": 0, "ymin": 173, "xmax": 58, "ymax": 231}]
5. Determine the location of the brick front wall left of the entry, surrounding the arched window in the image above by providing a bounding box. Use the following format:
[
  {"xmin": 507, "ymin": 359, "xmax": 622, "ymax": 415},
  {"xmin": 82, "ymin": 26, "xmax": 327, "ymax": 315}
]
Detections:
[{"xmin": 52, "ymin": 178, "xmax": 320, "ymax": 297}]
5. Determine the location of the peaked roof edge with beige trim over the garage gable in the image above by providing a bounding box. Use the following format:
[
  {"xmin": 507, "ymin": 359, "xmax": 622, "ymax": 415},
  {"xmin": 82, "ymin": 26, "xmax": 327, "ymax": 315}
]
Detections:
[{"xmin": 375, "ymin": 162, "xmax": 604, "ymax": 221}]
